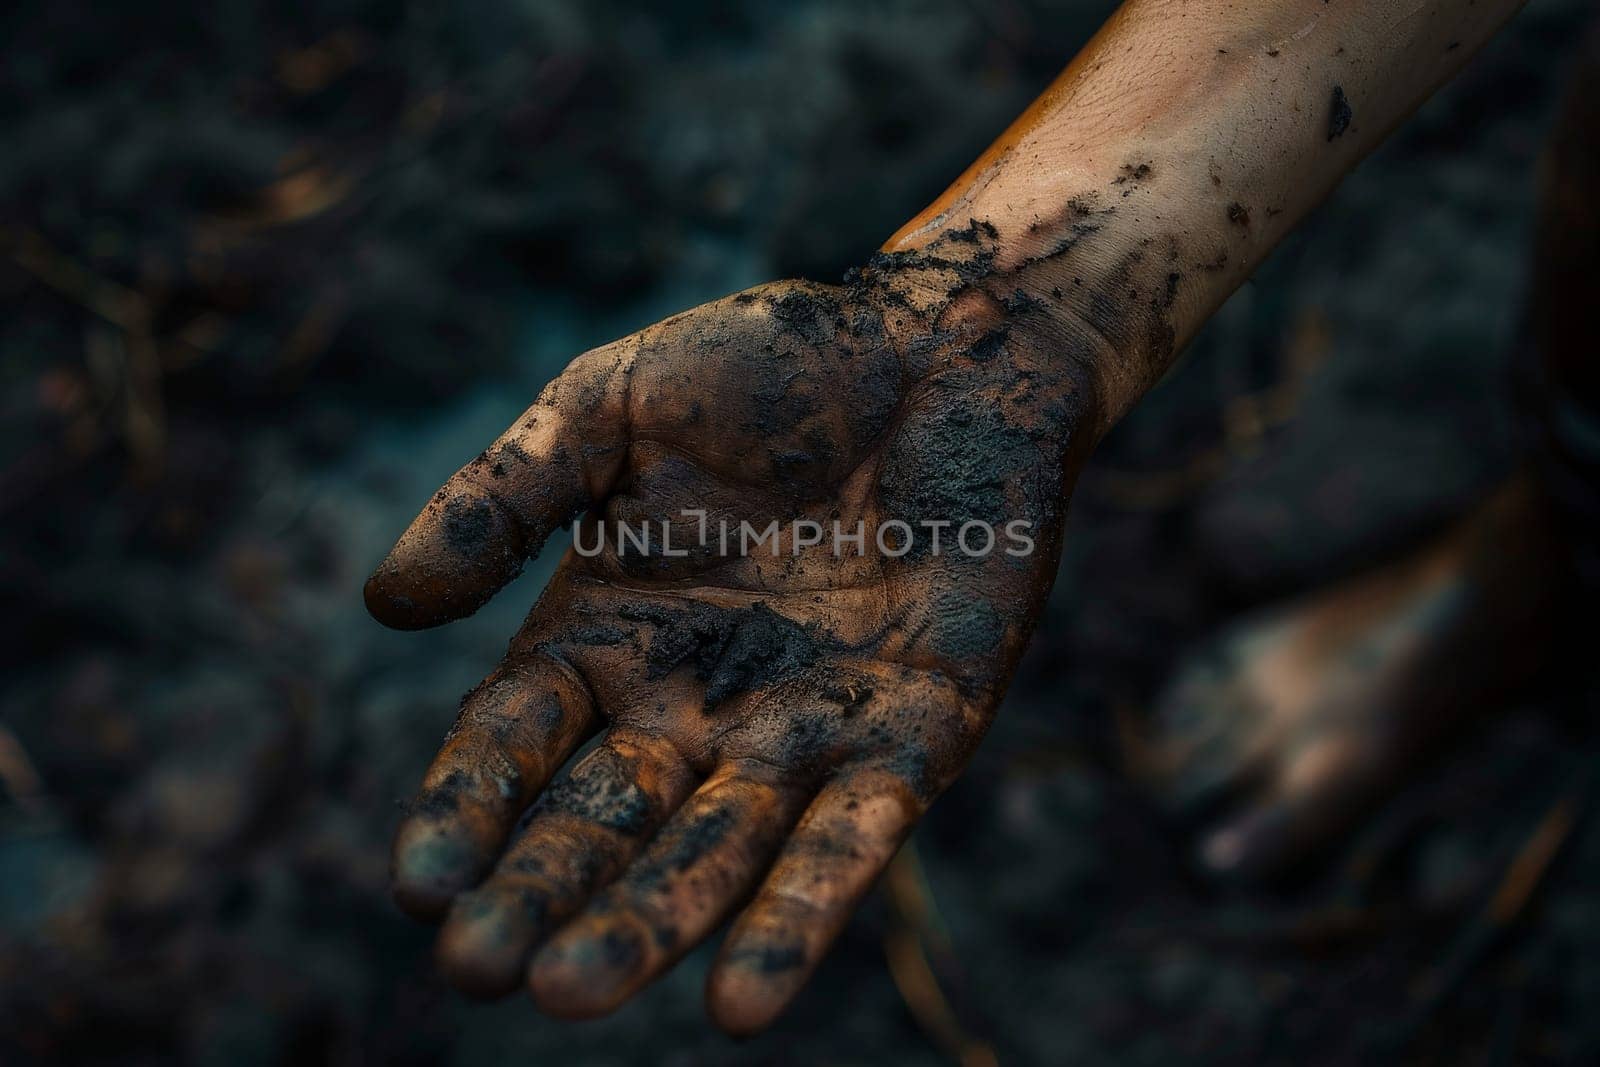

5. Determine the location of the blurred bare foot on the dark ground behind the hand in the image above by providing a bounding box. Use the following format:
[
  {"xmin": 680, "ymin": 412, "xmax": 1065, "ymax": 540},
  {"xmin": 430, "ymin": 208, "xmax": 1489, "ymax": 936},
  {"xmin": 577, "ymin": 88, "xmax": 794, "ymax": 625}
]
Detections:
[{"xmin": 1130, "ymin": 478, "xmax": 1562, "ymax": 881}]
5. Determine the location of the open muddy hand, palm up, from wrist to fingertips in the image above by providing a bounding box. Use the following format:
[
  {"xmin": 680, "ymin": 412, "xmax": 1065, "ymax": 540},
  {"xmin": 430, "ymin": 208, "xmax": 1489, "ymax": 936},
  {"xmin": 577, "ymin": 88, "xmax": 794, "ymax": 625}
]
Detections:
[{"xmin": 366, "ymin": 233, "xmax": 1093, "ymax": 1033}]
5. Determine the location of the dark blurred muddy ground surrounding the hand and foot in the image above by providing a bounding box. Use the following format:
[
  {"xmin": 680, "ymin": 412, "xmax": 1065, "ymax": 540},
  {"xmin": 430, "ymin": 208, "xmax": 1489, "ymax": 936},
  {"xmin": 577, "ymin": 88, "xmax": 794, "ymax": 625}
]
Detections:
[{"xmin": 0, "ymin": 0, "xmax": 1600, "ymax": 1065}]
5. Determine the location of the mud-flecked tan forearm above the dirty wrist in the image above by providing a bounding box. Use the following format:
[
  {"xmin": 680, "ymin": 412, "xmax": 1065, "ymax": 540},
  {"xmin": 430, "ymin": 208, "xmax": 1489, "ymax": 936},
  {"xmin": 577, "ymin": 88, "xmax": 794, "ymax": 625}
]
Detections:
[{"xmin": 885, "ymin": 0, "xmax": 1523, "ymax": 429}]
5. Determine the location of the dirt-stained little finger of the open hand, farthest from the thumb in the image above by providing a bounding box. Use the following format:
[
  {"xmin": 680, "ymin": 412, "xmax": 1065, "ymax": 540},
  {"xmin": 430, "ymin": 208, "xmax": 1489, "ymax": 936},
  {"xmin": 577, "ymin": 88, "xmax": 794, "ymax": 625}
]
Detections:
[{"xmin": 706, "ymin": 769, "xmax": 925, "ymax": 1035}]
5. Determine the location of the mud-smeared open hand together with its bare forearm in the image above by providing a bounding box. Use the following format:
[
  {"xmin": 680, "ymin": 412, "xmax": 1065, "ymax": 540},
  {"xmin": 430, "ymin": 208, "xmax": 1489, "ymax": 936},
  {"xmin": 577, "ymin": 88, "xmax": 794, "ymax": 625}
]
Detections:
[{"xmin": 366, "ymin": 0, "xmax": 1518, "ymax": 1033}]
